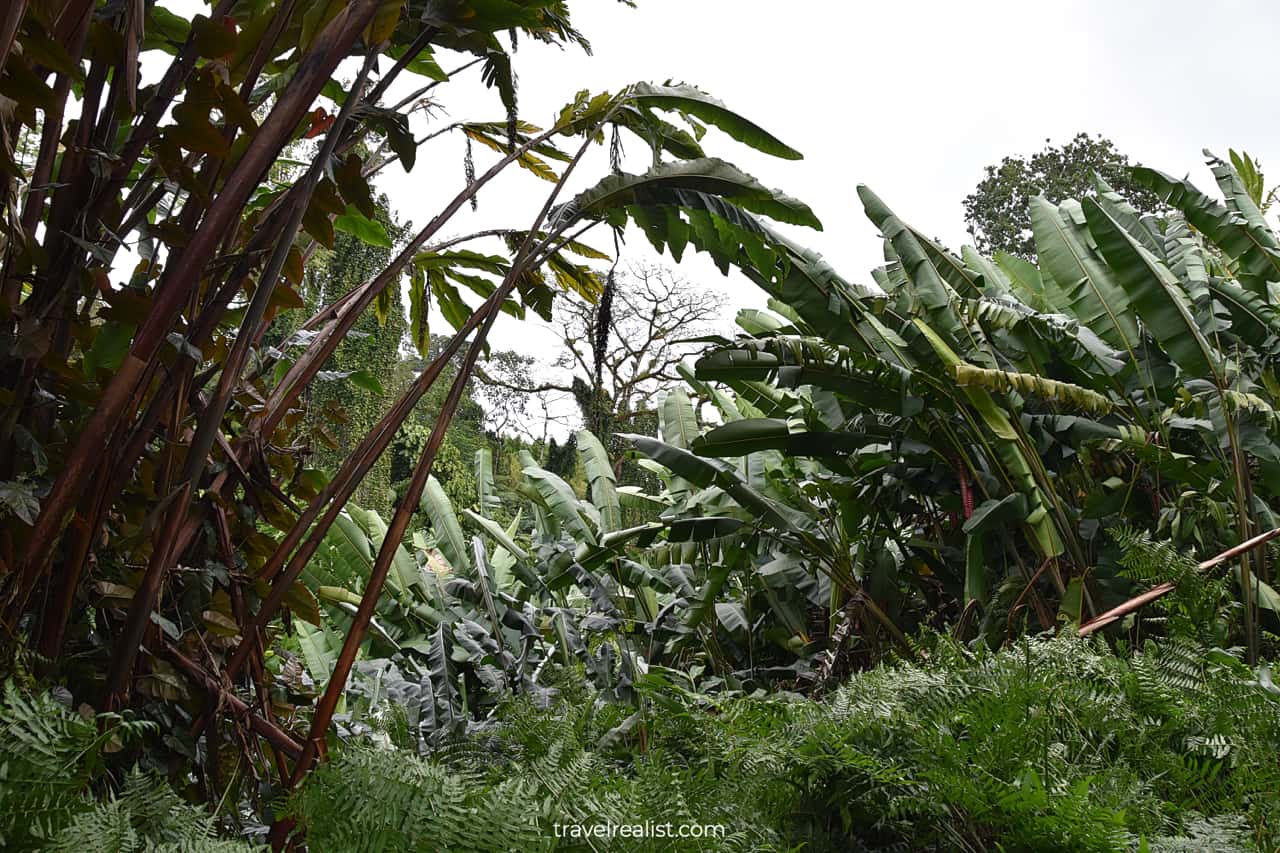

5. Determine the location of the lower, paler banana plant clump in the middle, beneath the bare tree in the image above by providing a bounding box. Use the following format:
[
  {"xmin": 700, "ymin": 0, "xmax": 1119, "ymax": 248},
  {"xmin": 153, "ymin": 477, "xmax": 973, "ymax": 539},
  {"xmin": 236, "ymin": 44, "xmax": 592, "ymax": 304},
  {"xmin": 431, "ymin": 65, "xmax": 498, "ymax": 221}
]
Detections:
[{"xmin": 297, "ymin": 432, "xmax": 668, "ymax": 738}]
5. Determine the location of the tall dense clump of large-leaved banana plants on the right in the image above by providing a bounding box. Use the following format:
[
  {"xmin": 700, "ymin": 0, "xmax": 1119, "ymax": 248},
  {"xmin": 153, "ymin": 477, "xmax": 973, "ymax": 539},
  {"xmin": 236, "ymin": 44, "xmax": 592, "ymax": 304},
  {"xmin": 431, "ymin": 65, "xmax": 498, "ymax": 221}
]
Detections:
[{"xmin": 632, "ymin": 151, "xmax": 1280, "ymax": 648}]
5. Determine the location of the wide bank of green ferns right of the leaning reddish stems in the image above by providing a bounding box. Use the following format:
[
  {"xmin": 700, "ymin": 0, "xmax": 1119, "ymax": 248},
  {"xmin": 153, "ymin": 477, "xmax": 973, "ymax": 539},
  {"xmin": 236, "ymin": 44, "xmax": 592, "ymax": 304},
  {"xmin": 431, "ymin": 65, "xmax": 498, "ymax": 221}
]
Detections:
[{"xmin": 291, "ymin": 637, "xmax": 1280, "ymax": 852}]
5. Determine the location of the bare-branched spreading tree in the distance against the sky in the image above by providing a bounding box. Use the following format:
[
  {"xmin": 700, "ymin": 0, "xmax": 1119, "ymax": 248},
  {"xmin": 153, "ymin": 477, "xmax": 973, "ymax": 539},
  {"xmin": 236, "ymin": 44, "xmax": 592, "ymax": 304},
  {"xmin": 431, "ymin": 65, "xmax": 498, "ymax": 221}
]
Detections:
[{"xmin": 476, "ymin": 265, "xmax": 724, "ymax": 437}]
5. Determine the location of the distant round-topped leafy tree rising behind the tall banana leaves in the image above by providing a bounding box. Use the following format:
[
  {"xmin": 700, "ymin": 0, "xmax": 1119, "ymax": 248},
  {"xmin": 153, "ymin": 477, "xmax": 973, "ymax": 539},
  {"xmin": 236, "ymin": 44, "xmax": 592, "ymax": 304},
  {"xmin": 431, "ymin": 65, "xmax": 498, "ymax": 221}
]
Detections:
[{"xmin": 964, "ymin": 132, "xmax": 1161, "ymax": 259}]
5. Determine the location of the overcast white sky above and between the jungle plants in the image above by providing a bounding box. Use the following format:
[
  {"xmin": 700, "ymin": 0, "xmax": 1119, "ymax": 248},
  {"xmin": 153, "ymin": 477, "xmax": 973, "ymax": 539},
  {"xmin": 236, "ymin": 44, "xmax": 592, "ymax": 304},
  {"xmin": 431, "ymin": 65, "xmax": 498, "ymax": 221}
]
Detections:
[{"xmin": 154, "ymin": 0, "xmax": 1280, "ymax": 432}]
